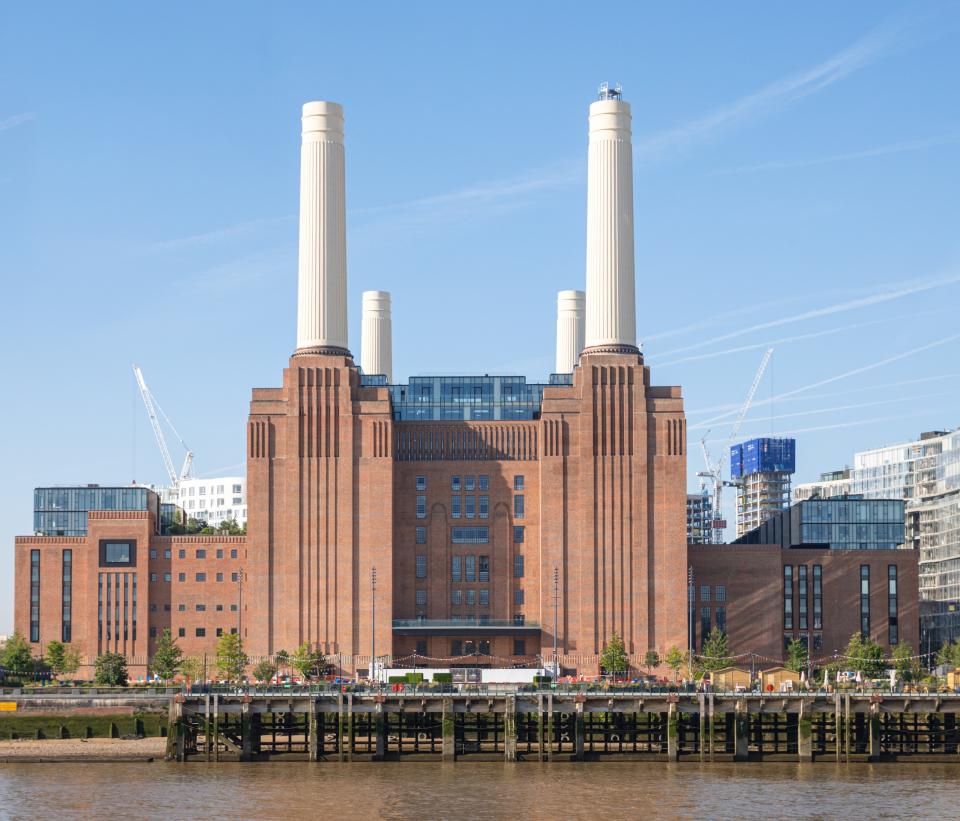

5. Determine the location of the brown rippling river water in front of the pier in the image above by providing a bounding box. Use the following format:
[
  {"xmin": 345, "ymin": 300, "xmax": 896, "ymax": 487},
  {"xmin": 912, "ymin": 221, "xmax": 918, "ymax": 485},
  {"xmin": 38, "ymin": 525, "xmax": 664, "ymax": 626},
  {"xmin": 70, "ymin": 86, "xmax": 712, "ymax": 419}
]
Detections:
[{"xmin": 0, "ymin": 762, "xmax": 960, "ymax": 821}]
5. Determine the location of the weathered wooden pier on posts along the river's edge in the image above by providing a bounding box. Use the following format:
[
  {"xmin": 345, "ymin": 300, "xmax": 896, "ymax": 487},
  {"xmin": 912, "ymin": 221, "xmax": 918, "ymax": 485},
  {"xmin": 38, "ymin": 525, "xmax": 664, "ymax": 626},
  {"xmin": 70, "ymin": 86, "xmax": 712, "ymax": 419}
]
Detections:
[{"xmin": 167, "ymin": 690, "xmax": 960, "ymax": 764}]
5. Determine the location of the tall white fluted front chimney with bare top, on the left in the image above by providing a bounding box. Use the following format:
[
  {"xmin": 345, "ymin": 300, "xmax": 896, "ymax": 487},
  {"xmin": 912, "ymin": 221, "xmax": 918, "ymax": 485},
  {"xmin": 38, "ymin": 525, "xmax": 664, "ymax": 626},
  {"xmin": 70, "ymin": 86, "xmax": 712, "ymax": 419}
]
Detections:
[{"xmin": 297, "ymin": 102, "xmax": 349, "ymax": 356}]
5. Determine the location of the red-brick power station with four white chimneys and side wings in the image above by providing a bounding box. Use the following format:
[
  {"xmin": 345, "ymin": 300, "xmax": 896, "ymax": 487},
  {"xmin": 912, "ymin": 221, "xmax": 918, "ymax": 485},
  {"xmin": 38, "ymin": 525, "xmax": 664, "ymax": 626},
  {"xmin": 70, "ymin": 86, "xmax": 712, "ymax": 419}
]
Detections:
[{"xmin": 15, "ymin": 90, "xmax": 917, "ymax": 677}]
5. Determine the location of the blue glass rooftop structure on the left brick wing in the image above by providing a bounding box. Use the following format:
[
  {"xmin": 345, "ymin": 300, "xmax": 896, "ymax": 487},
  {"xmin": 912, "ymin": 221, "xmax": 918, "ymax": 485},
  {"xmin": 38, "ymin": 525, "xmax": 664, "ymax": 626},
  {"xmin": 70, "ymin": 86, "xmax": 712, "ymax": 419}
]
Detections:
[{"xmin": 33, "ymin": 485, "xmax": 160, "ymax": 536}]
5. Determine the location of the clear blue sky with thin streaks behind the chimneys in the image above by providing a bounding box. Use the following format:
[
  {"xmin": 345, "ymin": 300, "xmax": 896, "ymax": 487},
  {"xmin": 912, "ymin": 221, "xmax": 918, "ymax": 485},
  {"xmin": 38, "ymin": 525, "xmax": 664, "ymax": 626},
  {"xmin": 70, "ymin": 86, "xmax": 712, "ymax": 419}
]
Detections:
[{"xmin": 0, "ymin": 2, "xmax": 960, "ymax": 632}]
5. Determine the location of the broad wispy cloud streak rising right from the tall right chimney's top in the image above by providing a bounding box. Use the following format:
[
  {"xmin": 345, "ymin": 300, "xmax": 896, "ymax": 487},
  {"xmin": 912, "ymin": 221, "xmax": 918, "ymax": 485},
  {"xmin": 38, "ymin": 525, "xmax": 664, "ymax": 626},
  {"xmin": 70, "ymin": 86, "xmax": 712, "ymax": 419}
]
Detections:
[{"xmin": 635, "ymin": 23, "xmax": 903, "ymax": 158}]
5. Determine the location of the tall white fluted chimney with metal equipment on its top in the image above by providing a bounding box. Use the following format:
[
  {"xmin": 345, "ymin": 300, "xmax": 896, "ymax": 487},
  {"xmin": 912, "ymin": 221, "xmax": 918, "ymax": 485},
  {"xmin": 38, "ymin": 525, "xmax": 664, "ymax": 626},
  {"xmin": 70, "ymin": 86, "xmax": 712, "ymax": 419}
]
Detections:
[{"xmin": 586, "ymin": 83, "xmax": 637, "ymax": 353}]
